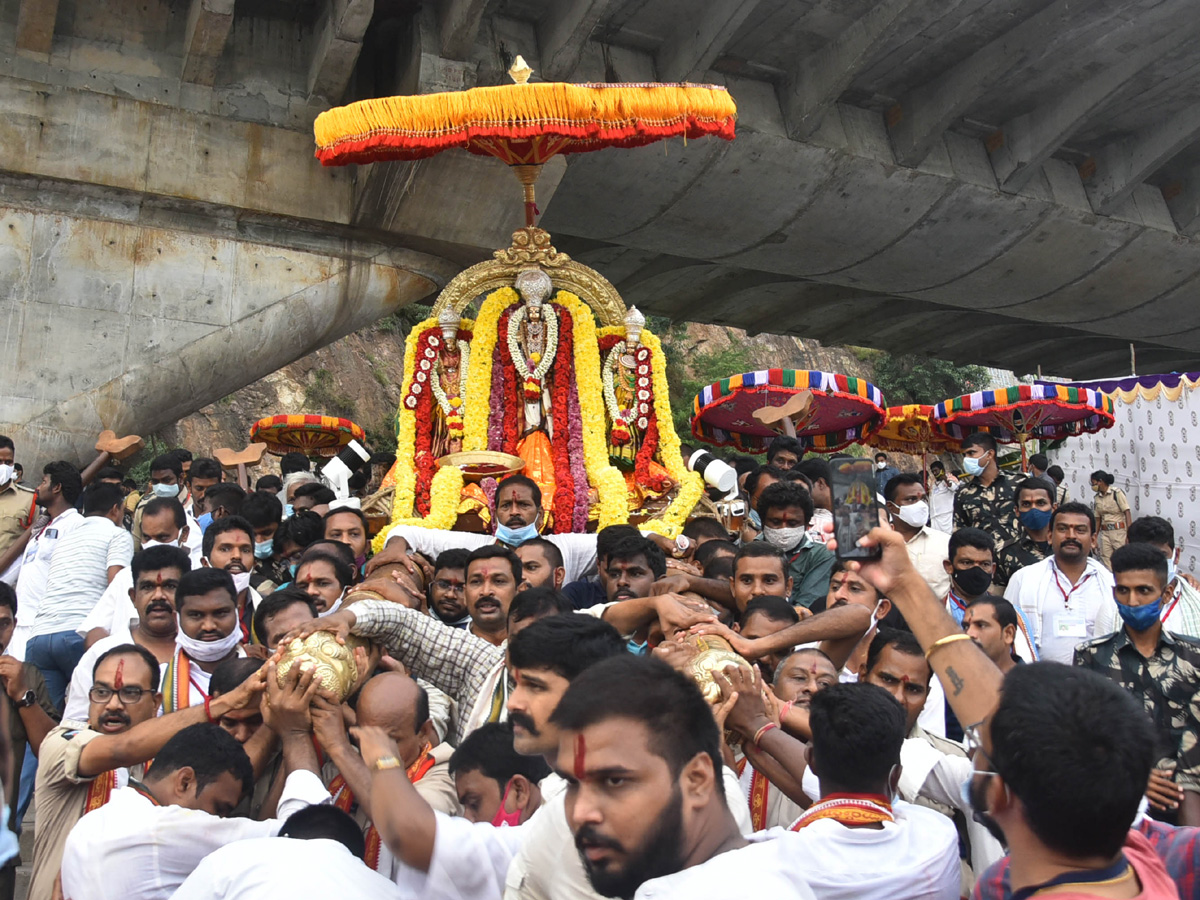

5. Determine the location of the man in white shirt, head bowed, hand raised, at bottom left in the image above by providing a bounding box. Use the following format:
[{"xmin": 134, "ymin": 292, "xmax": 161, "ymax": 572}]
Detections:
[{"xmin": 62, "ymin": 665, "xmax": 329, "ymax": 900}]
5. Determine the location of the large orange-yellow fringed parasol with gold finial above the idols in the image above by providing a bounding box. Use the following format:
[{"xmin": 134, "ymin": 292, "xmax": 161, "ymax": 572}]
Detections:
[{"xmin": 313, "ymin": 56, "xmax": 737, "ymax": 227}]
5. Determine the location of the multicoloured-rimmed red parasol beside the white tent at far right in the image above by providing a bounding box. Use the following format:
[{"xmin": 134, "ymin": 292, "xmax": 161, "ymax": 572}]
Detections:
[{"xmin": 934, "ymin": 384, "xmax": 1116, "ymax": 469}]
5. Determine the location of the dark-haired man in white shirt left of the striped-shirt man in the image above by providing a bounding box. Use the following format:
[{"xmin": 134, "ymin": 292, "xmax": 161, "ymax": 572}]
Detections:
[{"xmin": 7, "ymin": 462, "xmax": 83, "ymax": 659}]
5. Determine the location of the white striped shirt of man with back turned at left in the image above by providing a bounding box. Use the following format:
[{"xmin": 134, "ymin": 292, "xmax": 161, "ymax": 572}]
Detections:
[{"xmin": 31, "ymin": 516, "xmax": 133, "ymax": 637}]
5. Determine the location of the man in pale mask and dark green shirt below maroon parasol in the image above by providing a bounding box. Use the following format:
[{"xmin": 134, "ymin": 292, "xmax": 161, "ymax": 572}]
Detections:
[{"xmin": 758, "ymin": 482, "xmax": 838, "ymax": 608}]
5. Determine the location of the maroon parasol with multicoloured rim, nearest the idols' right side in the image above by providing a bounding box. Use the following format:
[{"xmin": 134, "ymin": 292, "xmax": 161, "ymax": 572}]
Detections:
[{"xmin": 691, "ymin": 368, "xmax": 886, "ymax": 454}]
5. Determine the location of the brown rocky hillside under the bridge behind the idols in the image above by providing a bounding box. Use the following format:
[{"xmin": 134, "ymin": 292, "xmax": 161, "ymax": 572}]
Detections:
[{"xmin": 155, "ymin": 317, "xmax": 870, "ymax": 474}]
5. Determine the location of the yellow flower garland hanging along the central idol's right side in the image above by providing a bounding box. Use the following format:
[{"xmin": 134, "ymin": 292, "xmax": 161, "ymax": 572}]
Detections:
[{"xmin": 554, "ymin": 290, "xmax": 629, "ymax": 528}]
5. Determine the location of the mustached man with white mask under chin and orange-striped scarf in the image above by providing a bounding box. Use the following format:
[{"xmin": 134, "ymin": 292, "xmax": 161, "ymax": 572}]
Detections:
[{"xmin": 162, "ymin": 571, "xmax": 248, "ymax": 713}]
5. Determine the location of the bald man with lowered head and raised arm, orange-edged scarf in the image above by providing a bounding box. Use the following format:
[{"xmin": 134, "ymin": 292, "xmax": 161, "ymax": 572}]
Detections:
[{"xmin": 312, "ymin": 672, "xmax": 461, "ymax": 880}]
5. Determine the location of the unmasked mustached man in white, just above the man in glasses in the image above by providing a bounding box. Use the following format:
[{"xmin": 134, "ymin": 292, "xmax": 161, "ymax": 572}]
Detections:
[{"xmin": 62, "ymin": 546, "xmax": 192, "ymax": 722}]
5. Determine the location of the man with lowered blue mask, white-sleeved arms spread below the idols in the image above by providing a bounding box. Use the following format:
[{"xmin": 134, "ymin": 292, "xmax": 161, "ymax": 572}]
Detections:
[{"xmin": 367, "ymin": 475, "xmax": 596, "ymax": 583}]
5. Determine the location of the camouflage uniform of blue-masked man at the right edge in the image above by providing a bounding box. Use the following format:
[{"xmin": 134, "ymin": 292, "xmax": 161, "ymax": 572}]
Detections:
[{"xmin": 1075, "ymin": 628, "xmax": 1200, "ymax": 793}]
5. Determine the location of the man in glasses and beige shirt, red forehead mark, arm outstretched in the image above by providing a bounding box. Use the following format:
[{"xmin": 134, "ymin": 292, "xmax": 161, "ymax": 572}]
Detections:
[{"xmin": 29, "ymin": 643, "xmax": 263, "ymax": 900}]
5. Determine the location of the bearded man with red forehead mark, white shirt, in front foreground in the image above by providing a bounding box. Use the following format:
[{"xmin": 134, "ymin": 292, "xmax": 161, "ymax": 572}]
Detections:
[{"xmin": 547, "ymin": 654, "xmax": 815, "ymax": 900}]
